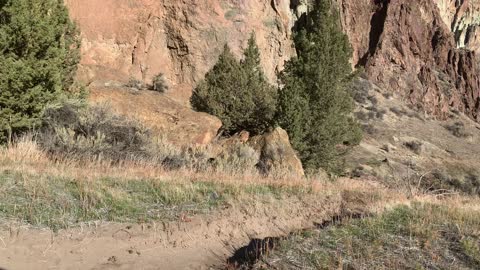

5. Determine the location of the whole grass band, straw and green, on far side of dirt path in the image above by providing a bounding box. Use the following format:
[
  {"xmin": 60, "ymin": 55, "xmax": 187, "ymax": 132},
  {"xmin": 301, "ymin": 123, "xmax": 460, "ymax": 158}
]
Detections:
[{"xmin": 0, "ymin": 137, "xmax": 352, "ymax": 229}]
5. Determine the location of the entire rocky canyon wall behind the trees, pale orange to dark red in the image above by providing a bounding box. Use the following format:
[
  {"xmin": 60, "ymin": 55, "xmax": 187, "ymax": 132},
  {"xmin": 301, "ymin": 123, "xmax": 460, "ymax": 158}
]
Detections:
[{"xmin": 66, "ymin": 0, "xmax": 480, "ymax": 120}]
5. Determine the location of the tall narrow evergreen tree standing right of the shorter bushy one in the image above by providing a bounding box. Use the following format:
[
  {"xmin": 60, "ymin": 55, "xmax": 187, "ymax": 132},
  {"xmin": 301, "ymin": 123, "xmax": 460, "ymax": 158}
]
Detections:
[{"xmin": 276, "ymin": 0, "xmax": 361, "ymax": 172}]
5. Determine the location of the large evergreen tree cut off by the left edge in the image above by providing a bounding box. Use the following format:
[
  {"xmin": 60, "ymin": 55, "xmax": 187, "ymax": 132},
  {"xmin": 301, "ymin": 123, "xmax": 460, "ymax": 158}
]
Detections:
[{"xmin": 0, "ymin": 0, "xmax": 79, "ymax": 142}]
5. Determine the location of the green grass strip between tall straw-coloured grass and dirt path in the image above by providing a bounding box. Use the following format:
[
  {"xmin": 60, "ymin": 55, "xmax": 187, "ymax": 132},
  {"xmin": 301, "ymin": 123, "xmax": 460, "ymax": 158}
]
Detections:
[{"xmin": 0, "ymin": 172, "xmax": 311, "ymax": 230}]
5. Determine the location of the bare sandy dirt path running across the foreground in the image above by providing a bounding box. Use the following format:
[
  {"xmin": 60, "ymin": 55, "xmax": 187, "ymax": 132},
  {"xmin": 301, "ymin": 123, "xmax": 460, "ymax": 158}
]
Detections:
[{"xmin": 0, "ymin": 179, "xmax": 398, "ymax": 270}]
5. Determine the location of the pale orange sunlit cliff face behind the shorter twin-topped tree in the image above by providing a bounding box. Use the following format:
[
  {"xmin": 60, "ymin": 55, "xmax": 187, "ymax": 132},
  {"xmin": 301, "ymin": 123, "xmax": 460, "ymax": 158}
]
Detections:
[{"xmin": 65, "ymin": 0, "xmax": 294, "ymax": 86}]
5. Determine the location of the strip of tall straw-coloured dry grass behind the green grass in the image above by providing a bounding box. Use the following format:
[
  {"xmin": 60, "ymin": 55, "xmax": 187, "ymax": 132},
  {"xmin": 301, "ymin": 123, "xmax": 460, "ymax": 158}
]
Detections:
[{"xmin": 0, "ymin": 136, "xmax": 322, "ymax": 193}]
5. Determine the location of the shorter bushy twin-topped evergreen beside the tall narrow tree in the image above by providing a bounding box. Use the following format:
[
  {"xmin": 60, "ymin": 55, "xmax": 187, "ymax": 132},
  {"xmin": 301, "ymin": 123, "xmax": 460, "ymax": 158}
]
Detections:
[{"xmin": 191, "ymin": 34, "xmax": 276, "ymax": 134}]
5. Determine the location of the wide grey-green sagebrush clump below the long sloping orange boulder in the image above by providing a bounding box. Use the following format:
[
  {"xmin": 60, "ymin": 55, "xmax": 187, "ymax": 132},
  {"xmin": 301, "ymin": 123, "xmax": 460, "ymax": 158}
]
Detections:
[{"xmin": 38, "ymin": 101, "xmax": 148, "ymax": 161}]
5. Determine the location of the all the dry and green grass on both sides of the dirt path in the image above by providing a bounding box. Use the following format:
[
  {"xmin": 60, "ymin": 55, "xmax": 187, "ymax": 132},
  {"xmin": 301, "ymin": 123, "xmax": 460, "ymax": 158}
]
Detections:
[{"xmin": 0, "ymin": 137, "xmax": 480, "ymax": 269}]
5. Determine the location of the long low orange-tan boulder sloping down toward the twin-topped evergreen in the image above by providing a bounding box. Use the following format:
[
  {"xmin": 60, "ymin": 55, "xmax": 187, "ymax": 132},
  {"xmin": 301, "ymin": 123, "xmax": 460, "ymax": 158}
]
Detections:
[{"xmin": 89, "ymin": 86, "xmax": 222, "ymax": 146}]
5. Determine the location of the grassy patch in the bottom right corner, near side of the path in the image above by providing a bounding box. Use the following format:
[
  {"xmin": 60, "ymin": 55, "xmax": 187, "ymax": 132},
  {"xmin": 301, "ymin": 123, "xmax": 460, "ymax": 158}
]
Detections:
[{"xmin": 265, "ymin": 204, "xmax": 480, "ymax": 269}]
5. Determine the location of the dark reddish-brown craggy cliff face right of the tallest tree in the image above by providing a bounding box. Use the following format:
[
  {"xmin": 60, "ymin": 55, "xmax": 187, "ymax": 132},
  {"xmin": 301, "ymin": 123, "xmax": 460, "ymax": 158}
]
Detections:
[{"xmin": 337, "ymin": 0, "xmax": 480, "ymax": 120}]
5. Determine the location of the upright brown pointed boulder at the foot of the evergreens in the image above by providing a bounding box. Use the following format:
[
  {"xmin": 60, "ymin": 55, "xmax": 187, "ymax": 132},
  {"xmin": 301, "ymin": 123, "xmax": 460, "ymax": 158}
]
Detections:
[{"xmin": 247, "ymin": 128, "xmax": 305, "ymax": 177}]
